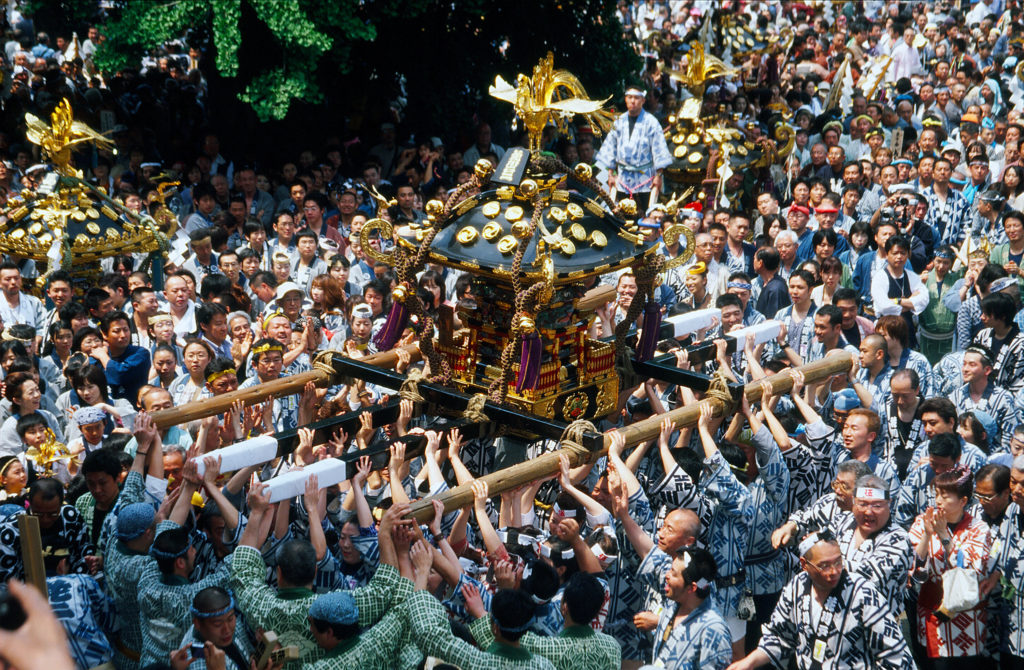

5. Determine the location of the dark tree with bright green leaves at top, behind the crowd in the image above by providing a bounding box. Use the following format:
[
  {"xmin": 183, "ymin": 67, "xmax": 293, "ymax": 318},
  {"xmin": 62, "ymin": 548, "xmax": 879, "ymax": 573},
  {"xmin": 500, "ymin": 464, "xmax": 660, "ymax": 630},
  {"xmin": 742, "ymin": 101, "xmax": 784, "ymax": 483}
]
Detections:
[{"xmin": 79, "ymin": 0, "xmax": 640, "ymax": 134}]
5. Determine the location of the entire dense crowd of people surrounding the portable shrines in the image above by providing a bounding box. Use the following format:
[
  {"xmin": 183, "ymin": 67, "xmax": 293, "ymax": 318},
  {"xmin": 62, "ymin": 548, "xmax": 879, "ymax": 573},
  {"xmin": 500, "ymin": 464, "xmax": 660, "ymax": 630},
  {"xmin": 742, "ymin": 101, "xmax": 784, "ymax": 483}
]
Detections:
[{"xmin": 0, "ymin": 0, "xmax": 1024, "ymax": 670}]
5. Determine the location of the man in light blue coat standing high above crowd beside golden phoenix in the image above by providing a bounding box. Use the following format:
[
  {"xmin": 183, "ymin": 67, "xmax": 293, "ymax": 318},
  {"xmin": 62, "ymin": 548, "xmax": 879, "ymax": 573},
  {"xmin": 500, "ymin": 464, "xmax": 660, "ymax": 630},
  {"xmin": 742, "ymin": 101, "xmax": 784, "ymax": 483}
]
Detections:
[{"xmin": 596, "ymin": 86, "xmax": 672, "ymax": 211}]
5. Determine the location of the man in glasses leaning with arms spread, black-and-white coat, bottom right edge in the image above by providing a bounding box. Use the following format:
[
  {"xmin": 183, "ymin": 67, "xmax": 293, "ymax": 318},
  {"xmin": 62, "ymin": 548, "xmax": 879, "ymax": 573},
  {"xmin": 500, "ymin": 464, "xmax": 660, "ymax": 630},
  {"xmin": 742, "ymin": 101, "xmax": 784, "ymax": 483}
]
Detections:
[{"xmin": 729, "ymin": 531, "xmax": 914, "ymax": 670}]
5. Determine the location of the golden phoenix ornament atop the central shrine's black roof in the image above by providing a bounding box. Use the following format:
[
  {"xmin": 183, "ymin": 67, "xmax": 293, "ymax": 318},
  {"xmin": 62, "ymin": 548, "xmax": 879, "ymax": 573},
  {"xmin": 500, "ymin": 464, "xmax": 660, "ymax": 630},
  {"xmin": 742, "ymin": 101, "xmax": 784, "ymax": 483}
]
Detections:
[{"xmin": 488, "ymin": 51, "xmax": 614, "ymax": 152}]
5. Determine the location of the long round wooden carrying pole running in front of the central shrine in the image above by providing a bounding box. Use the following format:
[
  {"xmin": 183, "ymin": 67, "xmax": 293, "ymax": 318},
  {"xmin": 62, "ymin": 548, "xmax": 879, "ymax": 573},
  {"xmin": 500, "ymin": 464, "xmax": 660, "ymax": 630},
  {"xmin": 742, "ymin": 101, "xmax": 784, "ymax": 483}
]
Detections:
[{"xmin": 411, "ymin": 349, "xmax": 853, "ymax": 522}]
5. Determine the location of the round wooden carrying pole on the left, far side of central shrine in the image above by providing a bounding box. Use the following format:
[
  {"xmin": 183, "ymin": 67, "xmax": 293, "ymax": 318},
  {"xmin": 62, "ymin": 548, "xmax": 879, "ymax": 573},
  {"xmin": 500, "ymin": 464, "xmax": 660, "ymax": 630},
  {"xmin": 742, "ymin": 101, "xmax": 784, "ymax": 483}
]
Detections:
[{"xmin": 153, "ymin": 343, "xmax": 421, "ymax": 430}]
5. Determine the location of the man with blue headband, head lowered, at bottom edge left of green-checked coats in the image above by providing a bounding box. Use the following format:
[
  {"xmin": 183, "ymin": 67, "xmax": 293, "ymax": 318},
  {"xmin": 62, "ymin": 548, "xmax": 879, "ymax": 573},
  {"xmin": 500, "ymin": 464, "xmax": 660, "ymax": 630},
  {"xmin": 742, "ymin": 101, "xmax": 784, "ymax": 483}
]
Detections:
[{"xmin": 178, "ymin": 586, "xmax": 256, "ymax": 670}]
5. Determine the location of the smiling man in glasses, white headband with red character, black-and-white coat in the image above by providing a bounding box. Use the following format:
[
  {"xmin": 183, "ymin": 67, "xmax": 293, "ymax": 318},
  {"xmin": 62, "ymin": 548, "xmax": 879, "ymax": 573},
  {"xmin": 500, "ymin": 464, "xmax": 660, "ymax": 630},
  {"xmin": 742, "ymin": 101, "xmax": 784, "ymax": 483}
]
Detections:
[{"xmin": 833, "ymin": 474, "xmax": 913, "ymax": 618}]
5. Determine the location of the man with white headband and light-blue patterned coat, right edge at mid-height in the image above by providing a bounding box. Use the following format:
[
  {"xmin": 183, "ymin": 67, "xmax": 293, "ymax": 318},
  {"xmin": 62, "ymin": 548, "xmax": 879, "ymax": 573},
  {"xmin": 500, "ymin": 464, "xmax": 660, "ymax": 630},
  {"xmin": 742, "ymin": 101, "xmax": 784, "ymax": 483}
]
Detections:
[{"xmin": 949, "ymin": 344, "xmax": 1020, "ymax": 453}]
